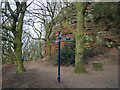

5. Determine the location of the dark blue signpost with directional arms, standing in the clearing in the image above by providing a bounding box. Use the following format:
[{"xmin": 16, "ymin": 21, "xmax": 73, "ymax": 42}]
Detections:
[{"xmin": 53, "ymin": 31, "xmax": 70, "ymax": 83}]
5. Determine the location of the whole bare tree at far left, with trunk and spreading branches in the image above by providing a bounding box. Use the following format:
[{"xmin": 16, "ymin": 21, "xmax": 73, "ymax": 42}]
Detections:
[{"xmin": 2, "ymin": 0, "xmax": 32, "ymax": 73}]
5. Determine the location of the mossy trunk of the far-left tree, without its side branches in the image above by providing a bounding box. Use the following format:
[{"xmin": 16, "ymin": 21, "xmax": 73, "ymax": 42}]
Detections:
[{"xmin": 14, "ymin": 2, "xmax": 26, "ymax": 73}]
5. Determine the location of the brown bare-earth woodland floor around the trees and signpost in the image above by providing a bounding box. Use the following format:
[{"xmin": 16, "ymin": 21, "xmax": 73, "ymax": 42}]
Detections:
[{"xmin": 2, "ymin": 48, "xmax": 118, "ymax": 88}]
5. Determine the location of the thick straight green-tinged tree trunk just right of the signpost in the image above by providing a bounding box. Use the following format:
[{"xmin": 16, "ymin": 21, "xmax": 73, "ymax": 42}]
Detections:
[{"xmin": 74, "ymin": 2, "xmax": 86, "ymax": 73}]
